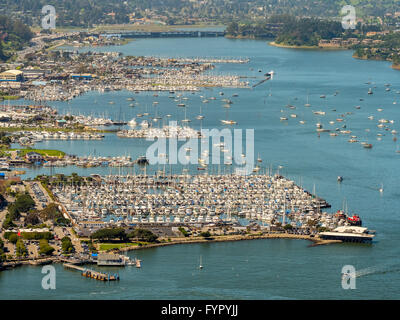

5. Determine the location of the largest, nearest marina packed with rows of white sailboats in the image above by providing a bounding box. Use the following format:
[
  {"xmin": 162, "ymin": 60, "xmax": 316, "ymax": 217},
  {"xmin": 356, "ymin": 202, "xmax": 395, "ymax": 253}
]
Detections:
[{"xmin": 52, "ymin": 175, "xmax": 376, "ymax": 232}]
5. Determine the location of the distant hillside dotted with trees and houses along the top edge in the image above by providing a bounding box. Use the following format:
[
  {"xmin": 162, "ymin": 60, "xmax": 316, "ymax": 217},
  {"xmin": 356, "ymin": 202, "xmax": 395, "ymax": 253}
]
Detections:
[{"xmin": 0, "ymin": 0, "xmax": 400, "ymax": 27}]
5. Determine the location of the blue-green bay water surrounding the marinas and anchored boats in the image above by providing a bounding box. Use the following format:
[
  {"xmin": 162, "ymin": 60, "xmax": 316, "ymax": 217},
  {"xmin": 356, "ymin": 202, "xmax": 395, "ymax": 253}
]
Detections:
[{"xmin": 0, "ymin": 38, "xmax": 400, "ymax": 299}]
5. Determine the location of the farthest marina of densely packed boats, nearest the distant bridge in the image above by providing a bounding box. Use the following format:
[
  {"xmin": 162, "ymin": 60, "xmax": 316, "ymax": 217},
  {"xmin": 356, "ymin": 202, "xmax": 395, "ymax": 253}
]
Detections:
[{"xmin": 20, "ymin": 51, "xmax": 249, "ymax": 102}]
